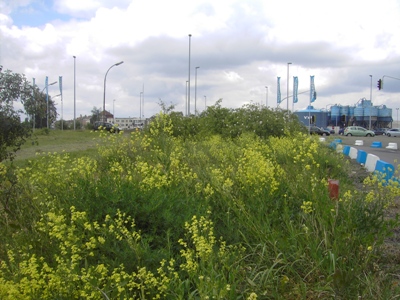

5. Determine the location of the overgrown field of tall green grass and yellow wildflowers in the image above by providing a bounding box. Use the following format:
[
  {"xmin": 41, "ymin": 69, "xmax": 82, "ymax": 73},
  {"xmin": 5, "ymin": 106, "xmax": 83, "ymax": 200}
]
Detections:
[{"xmin": 0, "ymin": 107, "xmax": 400, "ymax": 299}]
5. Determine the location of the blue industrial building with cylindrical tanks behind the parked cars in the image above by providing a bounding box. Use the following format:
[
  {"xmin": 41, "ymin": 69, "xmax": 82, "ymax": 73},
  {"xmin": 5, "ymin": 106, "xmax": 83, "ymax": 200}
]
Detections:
[{"xmin": 294, "ymin": 98, "xmax": 393, "ymax": 129}]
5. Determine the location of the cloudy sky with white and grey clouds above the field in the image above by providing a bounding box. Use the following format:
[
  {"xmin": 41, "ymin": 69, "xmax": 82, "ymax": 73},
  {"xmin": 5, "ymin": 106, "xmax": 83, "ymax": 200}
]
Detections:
[{"xmin": 0, "ymin": 0, "xmax": 400, "ymax": 120}]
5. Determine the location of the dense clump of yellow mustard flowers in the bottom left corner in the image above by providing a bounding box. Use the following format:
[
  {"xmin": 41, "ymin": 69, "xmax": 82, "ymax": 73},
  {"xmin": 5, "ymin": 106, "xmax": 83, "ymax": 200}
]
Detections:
[{"xmin": 0, "ymin": 207, "xmax": 169, "ymax": 299}]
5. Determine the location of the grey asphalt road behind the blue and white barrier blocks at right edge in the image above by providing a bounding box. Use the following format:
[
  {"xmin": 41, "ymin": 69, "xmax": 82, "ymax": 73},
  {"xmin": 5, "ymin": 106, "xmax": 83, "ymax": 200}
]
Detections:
[{"xmin": 331, "ymin": 134, "xmax": 400, "ymax": 169}]
